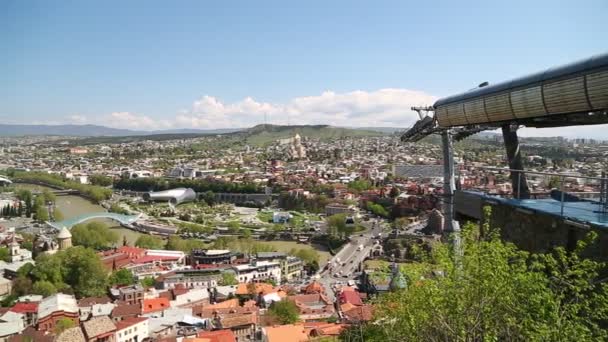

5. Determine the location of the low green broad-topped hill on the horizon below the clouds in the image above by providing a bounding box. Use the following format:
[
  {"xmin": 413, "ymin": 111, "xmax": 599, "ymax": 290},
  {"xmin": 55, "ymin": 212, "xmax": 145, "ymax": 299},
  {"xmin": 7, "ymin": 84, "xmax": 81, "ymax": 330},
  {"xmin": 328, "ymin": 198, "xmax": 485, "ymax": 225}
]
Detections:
[{"xmin": 238, "ymin": 125, "xmax": 384, "ymax": 146}]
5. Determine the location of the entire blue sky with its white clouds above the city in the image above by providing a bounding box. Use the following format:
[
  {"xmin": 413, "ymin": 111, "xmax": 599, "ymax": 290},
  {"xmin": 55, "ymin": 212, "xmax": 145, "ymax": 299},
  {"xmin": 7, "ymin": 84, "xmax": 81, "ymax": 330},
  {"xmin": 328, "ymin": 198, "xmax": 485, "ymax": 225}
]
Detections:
[{"xmin": 0, "ymin": 0, "xmax": 608, "ymax": 138}]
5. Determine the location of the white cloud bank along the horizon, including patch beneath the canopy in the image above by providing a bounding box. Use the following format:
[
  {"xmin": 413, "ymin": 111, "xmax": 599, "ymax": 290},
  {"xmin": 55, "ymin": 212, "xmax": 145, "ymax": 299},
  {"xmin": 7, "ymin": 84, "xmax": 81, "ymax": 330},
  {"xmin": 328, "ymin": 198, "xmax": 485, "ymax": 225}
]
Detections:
[{"xmin": 60, "ymin": 88, "xmax": 608, "ymax": 139}]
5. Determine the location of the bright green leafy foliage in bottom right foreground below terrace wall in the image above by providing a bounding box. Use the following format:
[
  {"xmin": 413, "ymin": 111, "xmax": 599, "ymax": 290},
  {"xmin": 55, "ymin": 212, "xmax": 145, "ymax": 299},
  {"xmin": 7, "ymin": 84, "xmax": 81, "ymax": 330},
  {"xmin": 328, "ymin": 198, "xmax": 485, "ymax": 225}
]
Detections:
[{"xmin": 342, "ymin": 210, "xmax": 608, "ymax": 342}]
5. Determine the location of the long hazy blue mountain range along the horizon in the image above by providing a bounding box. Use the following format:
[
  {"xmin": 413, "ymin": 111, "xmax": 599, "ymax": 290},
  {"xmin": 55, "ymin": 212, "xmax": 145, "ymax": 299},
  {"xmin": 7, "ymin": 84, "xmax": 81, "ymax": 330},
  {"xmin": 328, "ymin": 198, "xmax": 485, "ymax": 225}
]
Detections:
[{"xmin": 0, "ymin": 124, "xmax": 401, "ymax": 137}]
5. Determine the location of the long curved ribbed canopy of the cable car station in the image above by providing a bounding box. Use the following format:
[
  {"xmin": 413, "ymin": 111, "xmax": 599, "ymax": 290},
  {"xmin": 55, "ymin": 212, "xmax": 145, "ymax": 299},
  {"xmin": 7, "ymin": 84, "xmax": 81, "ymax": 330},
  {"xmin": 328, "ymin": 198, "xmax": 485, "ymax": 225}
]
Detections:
[{"xmin": 433, "ymin": 54, "xmax": 608, "ymax": 127}]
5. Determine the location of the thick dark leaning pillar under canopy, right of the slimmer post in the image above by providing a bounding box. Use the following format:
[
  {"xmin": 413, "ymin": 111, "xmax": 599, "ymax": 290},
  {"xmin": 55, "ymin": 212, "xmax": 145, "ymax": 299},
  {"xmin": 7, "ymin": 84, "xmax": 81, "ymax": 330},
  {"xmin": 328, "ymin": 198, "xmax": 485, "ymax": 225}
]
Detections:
[{"xmin": 502, "ymin": 125, "xmax": 530, "ymax": 199}]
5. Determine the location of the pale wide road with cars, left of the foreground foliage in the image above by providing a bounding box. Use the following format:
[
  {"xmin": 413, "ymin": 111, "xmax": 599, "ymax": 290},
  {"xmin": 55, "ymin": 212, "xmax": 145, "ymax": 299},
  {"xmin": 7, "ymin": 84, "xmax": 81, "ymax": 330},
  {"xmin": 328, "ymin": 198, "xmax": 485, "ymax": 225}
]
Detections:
[{"xmin": 315, "ymin": 219, "xmax": 386, "ymax": 301}]
